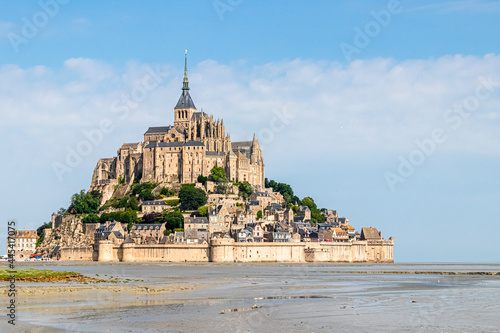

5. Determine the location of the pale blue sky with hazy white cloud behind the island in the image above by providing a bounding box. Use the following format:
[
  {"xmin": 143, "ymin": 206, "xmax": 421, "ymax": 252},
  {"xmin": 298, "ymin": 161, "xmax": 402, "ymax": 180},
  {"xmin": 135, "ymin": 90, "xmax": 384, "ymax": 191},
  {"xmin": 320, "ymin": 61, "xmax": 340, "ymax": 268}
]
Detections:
[{"xmin": 0, "ymin": 0, "xmax": 500, "ymax": 262}]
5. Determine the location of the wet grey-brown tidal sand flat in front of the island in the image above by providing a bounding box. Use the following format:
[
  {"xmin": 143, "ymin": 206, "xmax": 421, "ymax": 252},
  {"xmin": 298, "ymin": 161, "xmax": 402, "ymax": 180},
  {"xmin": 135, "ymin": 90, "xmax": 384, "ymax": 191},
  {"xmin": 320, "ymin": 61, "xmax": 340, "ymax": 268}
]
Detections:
[{"xmin": 0, "ymin": 262, "xmax": 500, "ymax": 332}]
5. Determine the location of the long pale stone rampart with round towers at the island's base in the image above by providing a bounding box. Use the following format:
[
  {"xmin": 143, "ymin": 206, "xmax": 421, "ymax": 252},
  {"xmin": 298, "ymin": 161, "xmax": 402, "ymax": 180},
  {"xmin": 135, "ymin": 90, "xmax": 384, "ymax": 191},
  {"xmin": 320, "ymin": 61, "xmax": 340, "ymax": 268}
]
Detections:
[{"xmin": 58, "ymin": 237, "xmax": 394, "ymax": 263}]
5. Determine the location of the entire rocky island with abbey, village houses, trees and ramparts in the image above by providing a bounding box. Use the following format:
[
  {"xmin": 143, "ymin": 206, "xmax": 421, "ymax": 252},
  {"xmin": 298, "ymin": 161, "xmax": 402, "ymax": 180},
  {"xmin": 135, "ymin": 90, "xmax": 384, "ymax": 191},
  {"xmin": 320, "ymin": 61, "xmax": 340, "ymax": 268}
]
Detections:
[{"xmin": 30, "ymin": 55, "xmax": 394, "ymax": 262}]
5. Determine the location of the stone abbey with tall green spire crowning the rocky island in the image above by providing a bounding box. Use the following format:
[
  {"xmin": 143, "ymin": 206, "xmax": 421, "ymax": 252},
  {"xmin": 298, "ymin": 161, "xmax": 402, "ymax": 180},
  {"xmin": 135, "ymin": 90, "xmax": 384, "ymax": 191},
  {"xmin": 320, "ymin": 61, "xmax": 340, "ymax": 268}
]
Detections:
[{"xmin": 91, "ymin": 55, "xmax": 265, "ymax": 190}]
